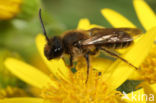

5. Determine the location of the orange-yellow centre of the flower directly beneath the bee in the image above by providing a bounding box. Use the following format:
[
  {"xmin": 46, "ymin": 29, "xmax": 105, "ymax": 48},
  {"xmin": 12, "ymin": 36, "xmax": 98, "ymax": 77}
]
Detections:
[{"xmin": 42, "ymin": 64, "xmax": 124, "ymax": 103}]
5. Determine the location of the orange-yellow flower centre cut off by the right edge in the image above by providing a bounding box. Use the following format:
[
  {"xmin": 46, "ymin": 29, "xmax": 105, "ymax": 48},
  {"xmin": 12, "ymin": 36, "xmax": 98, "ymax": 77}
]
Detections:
[{"xmin": 139, "ymin": 45, "xmax": 156, "ymax": 83}]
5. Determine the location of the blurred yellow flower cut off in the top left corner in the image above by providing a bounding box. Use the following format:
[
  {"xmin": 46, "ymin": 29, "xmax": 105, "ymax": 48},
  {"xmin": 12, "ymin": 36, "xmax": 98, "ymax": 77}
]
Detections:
[{"xmin": 0, "ymin": 0, "xmax": 22, "ymax": 20}]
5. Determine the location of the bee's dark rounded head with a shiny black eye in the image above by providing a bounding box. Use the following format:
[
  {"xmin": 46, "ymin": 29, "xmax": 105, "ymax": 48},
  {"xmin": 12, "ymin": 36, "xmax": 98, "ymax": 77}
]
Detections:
[{"xmin": 44, "ymin": 36, "xmax": 64, "ymax": 60}]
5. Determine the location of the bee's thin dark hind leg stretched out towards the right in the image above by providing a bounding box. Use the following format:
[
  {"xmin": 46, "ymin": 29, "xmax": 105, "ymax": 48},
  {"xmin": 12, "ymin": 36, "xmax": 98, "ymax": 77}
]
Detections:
[{"xmin": 100, "ymin": 48, "xmax": 138, "ymax": 70}]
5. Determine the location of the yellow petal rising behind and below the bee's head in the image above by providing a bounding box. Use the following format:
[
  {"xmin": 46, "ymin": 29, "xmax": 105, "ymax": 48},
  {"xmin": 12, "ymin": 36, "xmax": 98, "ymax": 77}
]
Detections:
[{"xmin": 36, "ymin": 34, "xmax": 69, "ymax": 80}]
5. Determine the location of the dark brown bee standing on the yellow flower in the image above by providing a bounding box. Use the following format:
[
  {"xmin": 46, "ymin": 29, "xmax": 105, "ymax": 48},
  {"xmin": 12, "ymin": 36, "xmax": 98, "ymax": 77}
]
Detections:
[{"xmin": 39, "ymin": 9, "xmax": 141, "ymax": 82}]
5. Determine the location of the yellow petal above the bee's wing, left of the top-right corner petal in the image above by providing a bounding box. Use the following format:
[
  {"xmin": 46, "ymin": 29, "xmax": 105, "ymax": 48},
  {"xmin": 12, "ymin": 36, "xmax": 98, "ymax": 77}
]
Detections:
[{"xmin": 101, "ymin": 8, "xmax": 136, "ymax": 28}]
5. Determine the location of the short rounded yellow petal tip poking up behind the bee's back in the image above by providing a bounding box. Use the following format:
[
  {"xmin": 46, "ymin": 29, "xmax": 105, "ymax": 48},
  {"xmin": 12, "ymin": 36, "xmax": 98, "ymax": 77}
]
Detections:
[{"xmin": 77, "ymin": 19, "xmax": 90, "ymax": 30}]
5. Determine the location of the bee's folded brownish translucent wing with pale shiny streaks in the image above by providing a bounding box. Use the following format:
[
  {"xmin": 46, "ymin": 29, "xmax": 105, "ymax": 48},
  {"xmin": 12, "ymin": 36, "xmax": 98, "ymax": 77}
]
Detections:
[{"xmin": 81, "ymin": 28, "xmax": 141, "ymax": 46}]
